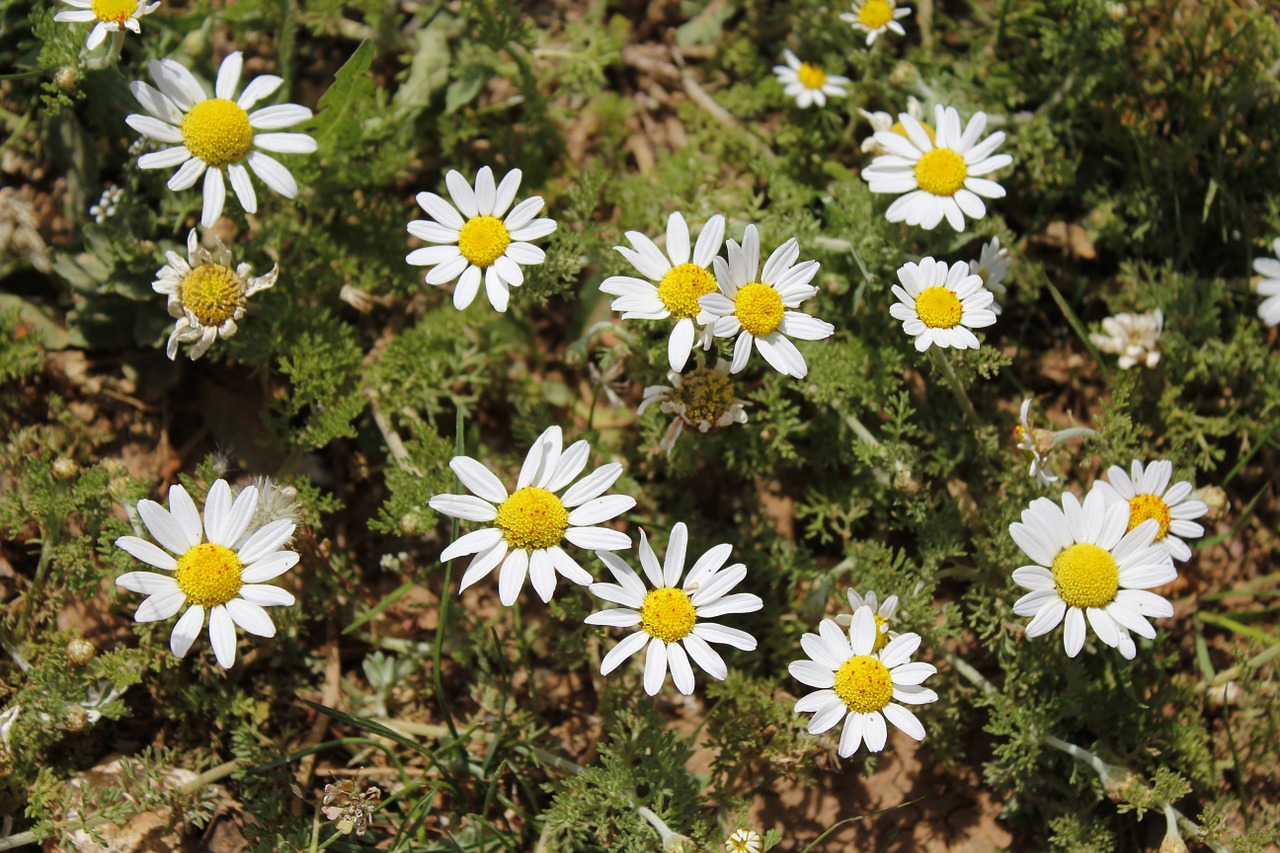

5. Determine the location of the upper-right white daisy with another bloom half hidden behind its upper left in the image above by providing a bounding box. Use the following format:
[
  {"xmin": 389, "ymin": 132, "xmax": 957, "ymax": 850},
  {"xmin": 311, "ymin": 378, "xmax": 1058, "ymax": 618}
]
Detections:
[{"xmin": 863, "ymin": 104, "xmax": 1014, "ymax": 231}]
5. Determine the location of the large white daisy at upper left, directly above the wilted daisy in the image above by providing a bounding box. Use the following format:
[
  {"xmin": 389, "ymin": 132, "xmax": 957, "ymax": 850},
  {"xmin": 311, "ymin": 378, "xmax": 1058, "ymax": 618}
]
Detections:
[{"xmin": 124, "ymin": 50, "xmax": 316, "ymax": 228}]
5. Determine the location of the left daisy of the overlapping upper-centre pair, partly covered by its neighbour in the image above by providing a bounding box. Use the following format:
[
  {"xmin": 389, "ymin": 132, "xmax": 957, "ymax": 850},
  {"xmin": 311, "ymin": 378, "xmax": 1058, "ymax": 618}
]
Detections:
[{"xmin": 600, "ymin": 210, "xmax": 724, "ymax": 370}]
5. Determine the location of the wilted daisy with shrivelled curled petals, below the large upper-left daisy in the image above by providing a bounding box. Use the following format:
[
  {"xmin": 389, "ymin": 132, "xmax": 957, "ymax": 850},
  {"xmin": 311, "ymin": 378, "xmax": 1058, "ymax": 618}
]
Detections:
[{"xmin": 151, "ymin": 228, "xmax": 279, "ymax": 361}]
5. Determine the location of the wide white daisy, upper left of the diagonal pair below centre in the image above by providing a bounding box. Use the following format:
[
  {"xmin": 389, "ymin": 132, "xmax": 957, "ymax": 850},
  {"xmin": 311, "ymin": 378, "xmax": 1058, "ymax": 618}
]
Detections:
[{"xmin": 429, "ymin": 427, "xmax": 636, "ymax": 607}]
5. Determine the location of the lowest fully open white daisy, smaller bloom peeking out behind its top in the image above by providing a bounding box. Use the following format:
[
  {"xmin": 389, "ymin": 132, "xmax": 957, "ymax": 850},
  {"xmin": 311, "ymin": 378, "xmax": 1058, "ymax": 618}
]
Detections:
[{"xmin": 787, "ymin": 607, "xmax": 938, "ymax": 758}]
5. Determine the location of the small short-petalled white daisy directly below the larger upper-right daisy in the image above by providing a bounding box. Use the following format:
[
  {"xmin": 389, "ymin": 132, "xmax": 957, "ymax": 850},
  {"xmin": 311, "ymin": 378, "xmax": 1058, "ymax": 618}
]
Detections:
[{"xmin": 888, "ymin": 257, "xmax": 996, "ymax": 352}]
